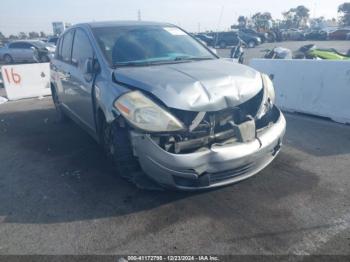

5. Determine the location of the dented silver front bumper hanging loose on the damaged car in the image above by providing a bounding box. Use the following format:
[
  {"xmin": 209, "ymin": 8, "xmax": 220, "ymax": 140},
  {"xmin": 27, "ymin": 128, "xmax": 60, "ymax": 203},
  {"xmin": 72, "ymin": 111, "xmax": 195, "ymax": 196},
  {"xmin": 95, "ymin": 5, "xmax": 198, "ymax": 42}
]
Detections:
[{"xmin": 131, "ymin": 108, "xmax": 286, "ymax": 190}]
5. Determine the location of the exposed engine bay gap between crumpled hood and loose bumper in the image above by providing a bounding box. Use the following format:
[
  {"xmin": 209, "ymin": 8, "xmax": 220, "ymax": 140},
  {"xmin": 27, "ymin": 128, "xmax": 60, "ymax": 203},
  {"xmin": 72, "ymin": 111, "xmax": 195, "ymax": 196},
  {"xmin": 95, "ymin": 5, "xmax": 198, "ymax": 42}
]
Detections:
[{"xmin": 152, "ymin": 89, "xmax": 279, "ymax": 154}]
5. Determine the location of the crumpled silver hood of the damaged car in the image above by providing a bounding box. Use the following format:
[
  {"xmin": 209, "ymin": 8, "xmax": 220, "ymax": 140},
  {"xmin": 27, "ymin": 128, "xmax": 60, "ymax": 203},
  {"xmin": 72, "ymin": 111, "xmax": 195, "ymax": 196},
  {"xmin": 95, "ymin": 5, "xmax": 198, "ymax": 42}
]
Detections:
[{"xmin": 114, "ymin": 59, "xmax": 262, "ymax": 112}]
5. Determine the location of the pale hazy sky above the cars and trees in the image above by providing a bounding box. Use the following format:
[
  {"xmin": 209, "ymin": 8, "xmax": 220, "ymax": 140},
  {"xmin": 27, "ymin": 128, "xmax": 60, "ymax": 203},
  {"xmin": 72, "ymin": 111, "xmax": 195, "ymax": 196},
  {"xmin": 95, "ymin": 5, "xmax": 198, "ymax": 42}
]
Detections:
[{"xmin": 0, "ymin": 0, "xmax": 348, "ymax": 35}]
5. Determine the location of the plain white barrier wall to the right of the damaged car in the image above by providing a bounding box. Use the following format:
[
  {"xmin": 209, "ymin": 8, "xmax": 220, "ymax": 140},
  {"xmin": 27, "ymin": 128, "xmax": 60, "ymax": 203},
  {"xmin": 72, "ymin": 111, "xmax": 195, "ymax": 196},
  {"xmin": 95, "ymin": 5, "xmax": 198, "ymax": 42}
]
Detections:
[{"xmin": 250, "ymin": 59, "xmax": 350, "ymax": 123}]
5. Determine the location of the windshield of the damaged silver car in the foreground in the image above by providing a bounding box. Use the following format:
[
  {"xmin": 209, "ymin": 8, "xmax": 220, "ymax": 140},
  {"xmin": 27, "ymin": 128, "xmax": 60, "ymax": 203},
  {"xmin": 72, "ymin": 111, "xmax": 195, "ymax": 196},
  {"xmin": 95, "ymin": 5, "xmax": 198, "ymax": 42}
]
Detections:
[{"xmin": 93, "ymin": 26, "xmax": 216, "ymax": 67}]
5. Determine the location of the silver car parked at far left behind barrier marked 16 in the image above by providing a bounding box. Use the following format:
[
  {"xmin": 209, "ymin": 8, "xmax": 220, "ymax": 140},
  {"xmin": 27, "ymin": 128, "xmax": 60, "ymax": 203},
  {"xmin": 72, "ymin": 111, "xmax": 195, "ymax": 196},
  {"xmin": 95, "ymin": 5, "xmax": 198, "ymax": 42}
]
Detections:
[{"xmin": 0, "ymin": 40, "xmax": 55, "ymax": 64}]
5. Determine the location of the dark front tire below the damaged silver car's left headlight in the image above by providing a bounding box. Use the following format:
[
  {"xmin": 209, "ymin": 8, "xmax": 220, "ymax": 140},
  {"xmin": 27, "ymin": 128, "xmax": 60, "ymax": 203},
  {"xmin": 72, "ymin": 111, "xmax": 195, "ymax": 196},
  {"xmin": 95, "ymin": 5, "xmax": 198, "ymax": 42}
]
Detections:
[{"xmin": 100, "ymin": 119, "xmax": 142, "ymax": 183}]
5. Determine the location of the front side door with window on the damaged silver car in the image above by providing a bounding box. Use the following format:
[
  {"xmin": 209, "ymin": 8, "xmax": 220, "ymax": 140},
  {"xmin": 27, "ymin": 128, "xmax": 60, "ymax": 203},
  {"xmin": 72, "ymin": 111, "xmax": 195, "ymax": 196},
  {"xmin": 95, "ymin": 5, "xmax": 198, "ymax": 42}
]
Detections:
[{"xmin": 71, "ymin": 28, "xmax": 95, "ymax": 130}]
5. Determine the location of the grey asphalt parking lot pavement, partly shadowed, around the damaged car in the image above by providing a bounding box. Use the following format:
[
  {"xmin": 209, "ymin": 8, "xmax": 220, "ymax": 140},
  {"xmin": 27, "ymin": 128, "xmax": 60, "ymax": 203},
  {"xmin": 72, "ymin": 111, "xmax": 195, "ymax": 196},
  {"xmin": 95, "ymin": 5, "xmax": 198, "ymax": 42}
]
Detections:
[{"xmin": 0, "ymin": 42, "xmax": 350, "ymax": 255}]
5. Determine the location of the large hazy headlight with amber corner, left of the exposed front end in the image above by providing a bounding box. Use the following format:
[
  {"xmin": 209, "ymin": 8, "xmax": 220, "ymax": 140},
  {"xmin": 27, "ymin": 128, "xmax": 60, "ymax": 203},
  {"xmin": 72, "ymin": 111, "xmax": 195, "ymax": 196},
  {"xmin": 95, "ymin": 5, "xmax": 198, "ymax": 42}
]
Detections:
[{"xmin": 114, "ymin": 91, "xmax": 185, "ymax": 132}]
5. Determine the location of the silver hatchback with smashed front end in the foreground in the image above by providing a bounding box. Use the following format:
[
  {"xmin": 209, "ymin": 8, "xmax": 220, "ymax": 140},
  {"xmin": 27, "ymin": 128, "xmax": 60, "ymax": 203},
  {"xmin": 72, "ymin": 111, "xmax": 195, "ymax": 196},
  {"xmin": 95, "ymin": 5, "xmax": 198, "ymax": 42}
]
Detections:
[{"xmin": 51, "ymin": 22, "xmax": 286, "ymax": 190}]
